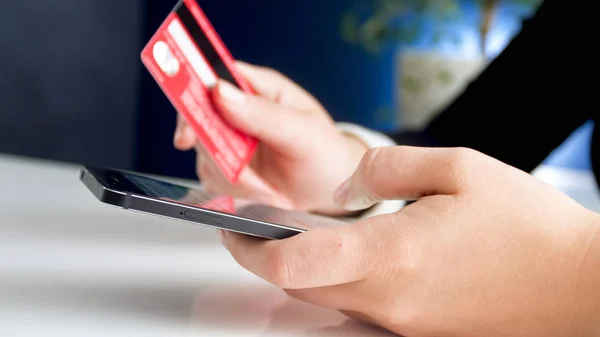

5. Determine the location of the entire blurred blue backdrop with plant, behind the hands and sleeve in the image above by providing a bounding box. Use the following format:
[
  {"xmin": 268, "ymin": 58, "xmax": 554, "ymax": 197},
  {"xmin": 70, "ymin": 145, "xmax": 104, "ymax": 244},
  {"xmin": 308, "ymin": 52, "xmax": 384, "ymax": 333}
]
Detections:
[{"xmin": 0, "ymin": 0, "xmax": 592, "ymax": 178}]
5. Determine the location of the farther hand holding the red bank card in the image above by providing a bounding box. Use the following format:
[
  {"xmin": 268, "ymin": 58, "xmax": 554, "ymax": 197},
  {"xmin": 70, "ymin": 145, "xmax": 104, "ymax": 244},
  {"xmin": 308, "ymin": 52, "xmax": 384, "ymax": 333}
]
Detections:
[{"xmin": 175, "ymin": 62, "xmax": 367, "ymax": 214}]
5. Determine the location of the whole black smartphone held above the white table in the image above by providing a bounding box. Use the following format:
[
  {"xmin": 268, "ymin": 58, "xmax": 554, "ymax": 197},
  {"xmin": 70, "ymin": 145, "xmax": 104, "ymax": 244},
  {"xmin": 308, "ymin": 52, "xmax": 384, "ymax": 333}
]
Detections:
[{"xmin": 80, "ymin": 167, "xmax": 346, "ymax": 239}]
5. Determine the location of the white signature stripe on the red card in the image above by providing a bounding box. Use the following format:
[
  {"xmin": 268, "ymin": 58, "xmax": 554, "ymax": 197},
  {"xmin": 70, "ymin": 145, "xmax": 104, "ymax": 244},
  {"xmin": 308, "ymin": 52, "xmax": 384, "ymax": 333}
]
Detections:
[{"xmin": 167, "ymin": 19, "xmax": 217, "ymax": 88}]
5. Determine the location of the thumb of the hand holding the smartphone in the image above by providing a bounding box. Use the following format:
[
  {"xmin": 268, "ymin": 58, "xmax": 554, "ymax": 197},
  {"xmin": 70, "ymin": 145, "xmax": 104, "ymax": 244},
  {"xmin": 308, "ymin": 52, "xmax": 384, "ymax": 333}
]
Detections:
[{"xmin": 334, "ymin": 146, "xmax": 475, "ymax": 211}]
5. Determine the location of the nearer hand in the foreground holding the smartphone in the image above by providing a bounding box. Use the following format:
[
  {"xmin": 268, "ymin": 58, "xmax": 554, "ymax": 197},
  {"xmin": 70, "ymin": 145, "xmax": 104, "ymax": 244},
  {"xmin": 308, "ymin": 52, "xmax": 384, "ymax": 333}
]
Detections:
[{"xmin": 222, "ymin": 147, "xmax": 600, "ymax": 337}]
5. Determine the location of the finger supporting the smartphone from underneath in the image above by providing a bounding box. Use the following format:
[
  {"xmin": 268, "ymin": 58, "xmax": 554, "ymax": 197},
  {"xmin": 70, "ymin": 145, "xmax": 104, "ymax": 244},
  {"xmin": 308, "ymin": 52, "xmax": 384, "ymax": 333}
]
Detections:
[{"xmin": 222, "ymin": 226, "xmax": 370, "ymax": 289}]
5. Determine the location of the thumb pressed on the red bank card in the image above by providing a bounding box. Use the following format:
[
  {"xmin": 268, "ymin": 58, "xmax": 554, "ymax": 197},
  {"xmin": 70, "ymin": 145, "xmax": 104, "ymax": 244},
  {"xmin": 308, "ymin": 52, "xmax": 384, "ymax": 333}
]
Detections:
[{"xmin": 213, "ymin": 80, "xmax": 303, "ymax": 153}]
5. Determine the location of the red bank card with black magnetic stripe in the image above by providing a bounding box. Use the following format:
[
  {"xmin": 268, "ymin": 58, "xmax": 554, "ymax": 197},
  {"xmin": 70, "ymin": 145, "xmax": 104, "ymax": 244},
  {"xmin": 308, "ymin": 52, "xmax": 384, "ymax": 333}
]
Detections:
[{"xmin": 141, "ymin": 0, "xmax": 258, "ymax": 183}]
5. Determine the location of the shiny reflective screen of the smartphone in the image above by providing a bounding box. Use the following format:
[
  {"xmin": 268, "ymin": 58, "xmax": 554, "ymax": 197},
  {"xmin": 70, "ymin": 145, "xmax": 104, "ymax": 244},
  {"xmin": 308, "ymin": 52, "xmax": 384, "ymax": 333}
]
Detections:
[{"xmin": 90, "ymin": 169, "xmax": 347, "ymax": 230}]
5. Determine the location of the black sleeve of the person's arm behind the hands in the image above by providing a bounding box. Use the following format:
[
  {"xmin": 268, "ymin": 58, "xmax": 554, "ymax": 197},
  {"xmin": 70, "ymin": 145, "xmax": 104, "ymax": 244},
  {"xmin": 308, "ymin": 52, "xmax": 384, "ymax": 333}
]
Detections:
[{"xmin": 391, "ymin": 0, "xmax": 589, "ymax": 172}]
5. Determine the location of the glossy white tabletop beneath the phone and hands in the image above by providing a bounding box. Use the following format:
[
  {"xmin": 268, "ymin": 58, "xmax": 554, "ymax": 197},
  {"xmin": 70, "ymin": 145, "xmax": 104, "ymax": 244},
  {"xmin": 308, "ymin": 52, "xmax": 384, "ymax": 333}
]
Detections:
[{"xmin": 0, "ymin": 156, "xmax": 600, "ymax": 337}]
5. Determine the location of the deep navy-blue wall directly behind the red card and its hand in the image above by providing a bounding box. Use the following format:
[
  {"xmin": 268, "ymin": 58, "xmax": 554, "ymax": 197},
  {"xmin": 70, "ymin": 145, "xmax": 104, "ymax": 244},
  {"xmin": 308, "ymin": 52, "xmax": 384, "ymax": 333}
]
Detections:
[{"xmin": 137, "ymin": 0, "xmax": 394, "ymax": 176}]
